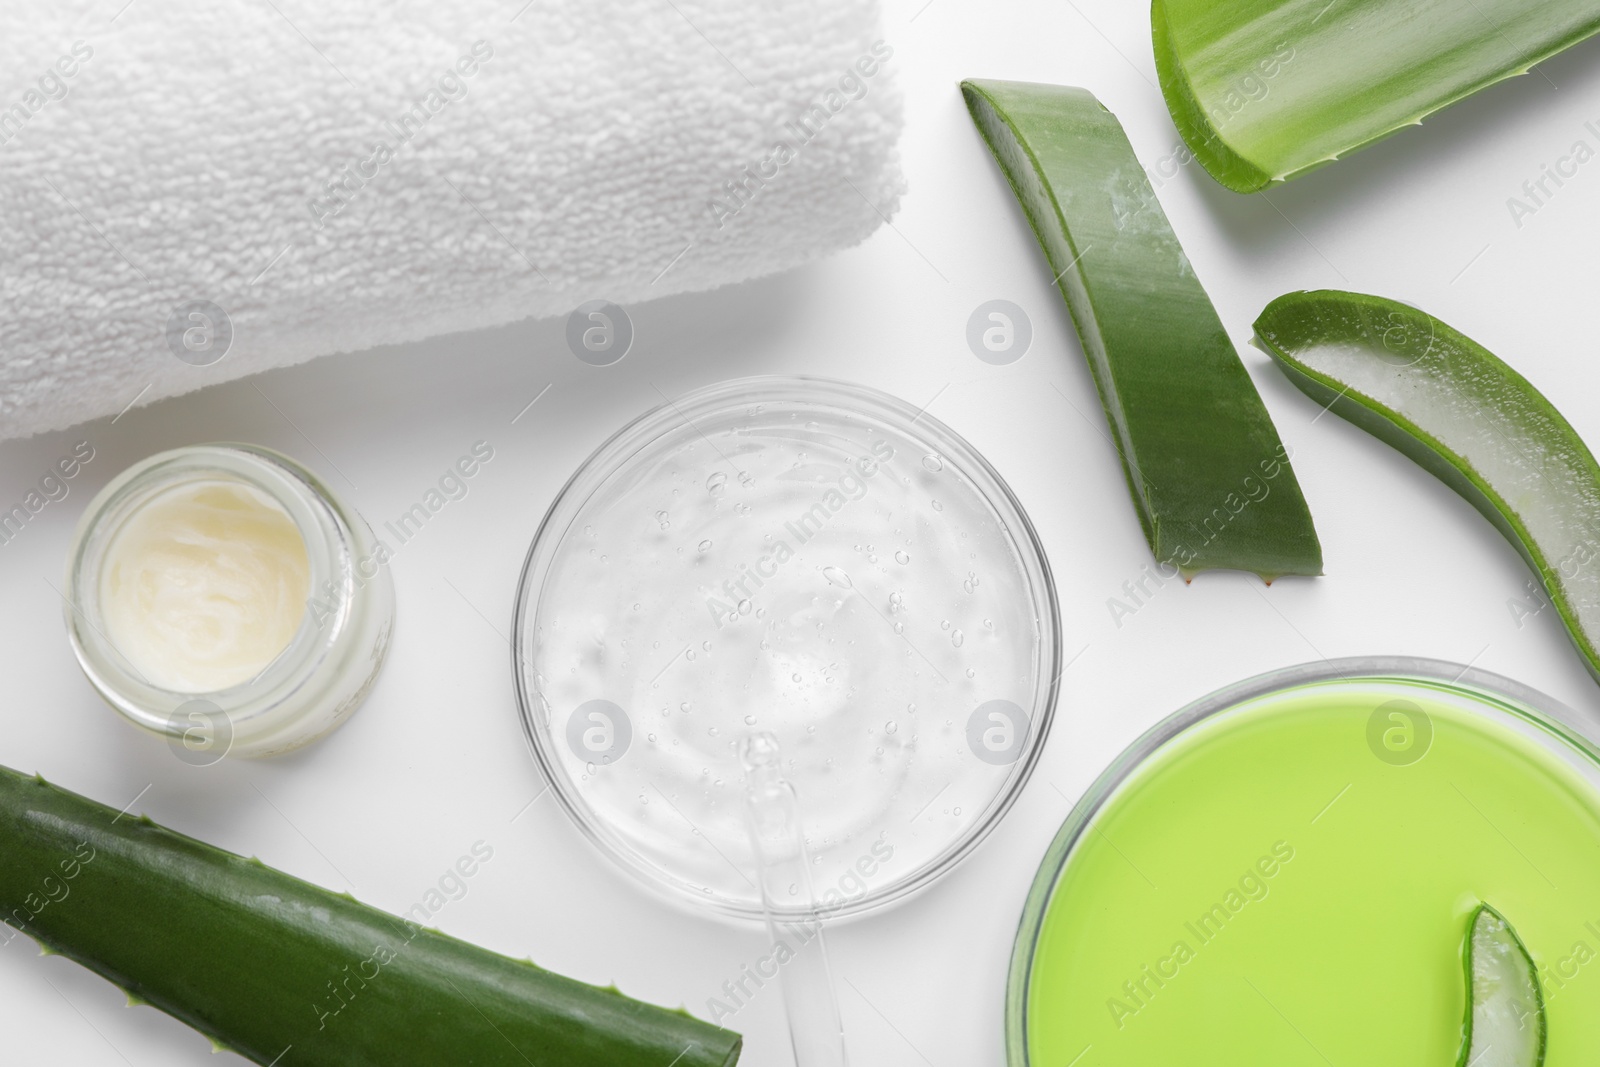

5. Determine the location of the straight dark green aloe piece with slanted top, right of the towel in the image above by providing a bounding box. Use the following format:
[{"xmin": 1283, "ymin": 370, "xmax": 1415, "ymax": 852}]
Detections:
[{"xmin": 962, "ymin": 82, "xmax": 1322, "ymax": 581}]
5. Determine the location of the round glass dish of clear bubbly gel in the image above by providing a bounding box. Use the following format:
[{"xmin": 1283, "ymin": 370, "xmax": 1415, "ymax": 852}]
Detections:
[{"xmin": 512, "ymin": 378, "xmax": 1059, "ymax": 918}]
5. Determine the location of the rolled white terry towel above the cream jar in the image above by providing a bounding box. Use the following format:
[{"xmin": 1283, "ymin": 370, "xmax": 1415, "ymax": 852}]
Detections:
[{"xmin": 0, "ymin": 0, "xmax": 902, "ymax": 437}]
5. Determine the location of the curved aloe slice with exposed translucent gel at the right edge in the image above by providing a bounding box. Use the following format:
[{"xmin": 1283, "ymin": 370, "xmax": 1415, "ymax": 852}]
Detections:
[{"xmin": 1256, "ymin": 291, "xmax": 1600, "ymax": 680}]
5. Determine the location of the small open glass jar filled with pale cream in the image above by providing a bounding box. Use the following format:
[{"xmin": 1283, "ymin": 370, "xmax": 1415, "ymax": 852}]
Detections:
[{"xmin": 66, "ymin": 445, "xmax": 394, "ymax": 765}]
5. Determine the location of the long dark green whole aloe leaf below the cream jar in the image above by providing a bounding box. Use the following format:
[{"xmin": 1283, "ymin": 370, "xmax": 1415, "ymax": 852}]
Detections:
[{"xmin": 0, "ymin": 768, "xmax": 741, "ymax": 1067}]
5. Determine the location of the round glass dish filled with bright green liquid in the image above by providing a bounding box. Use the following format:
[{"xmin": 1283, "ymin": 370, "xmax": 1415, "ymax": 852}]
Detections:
[{"xmin": 1005, "ymin": 659, "xmax": 1600, "ymax": 1067}]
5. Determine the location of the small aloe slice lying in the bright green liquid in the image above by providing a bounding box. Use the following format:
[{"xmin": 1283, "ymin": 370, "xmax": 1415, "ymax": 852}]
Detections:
[{"xmin": 1458, "ymin": 904, "xmax": 1546, "ymax": 1067}]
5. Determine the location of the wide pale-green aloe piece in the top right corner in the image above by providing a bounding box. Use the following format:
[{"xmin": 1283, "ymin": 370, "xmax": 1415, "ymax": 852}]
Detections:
[{"xmin": 1150, "ymin": 0, "xmax": 1600, "ymax": 192}]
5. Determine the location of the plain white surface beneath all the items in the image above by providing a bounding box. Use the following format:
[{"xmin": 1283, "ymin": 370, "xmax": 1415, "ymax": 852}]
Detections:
[{"xmin": 0, "ymin": 0, "xmax": 1600, "ymax": 1067}]
